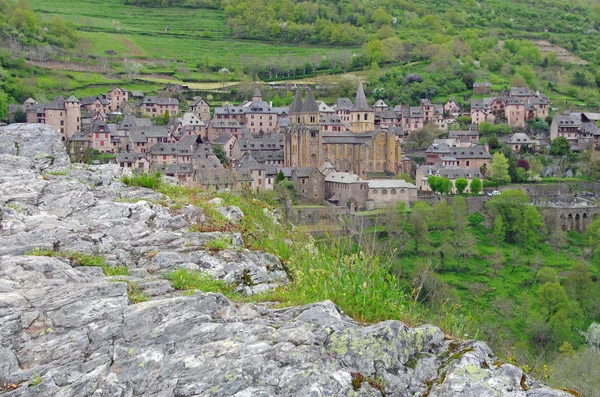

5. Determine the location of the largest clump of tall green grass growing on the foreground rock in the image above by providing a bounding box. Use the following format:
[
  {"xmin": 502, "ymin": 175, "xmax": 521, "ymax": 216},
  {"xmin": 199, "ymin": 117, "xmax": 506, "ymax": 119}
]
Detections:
[{"xmin": 255, "ymin": 239, "xmax": 419, "ymax": 323}]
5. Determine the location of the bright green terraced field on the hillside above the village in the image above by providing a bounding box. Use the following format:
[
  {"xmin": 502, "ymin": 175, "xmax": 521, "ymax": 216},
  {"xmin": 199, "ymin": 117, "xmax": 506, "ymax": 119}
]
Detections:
[{"xmin": 30, "ymin": 0, "xmax": 346, "ymax": 68}]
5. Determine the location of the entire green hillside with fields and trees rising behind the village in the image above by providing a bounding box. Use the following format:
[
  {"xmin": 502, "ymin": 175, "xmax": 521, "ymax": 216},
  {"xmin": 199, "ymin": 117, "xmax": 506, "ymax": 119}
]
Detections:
[{"xmin": 3, "ymin": 0, "xmax": 600, "ymax": 109}]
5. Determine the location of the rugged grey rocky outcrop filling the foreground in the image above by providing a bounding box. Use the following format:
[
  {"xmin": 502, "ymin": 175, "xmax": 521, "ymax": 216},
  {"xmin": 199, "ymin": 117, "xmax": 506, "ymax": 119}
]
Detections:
[{"xmin": 0, "ymin": 126, "xmax": 568, "ymax": 397}]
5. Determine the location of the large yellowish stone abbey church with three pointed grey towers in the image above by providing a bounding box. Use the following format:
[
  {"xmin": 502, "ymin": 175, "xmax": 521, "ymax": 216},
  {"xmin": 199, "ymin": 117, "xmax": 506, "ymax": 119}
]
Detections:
[{"xmin": 284, "ymin": 84, "xmax": 402, "ymax": 178}]
